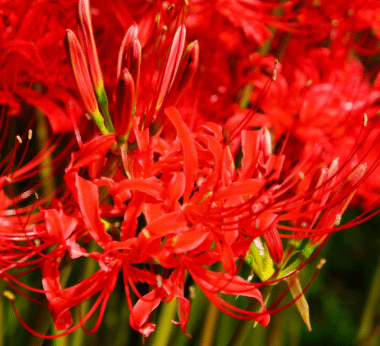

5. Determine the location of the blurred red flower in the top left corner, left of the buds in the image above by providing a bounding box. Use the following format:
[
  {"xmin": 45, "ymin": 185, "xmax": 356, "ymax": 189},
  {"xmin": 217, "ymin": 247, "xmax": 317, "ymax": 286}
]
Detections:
[{"xmin": 0, "ymin": 0, "xmax": 80, "ymax": 132}]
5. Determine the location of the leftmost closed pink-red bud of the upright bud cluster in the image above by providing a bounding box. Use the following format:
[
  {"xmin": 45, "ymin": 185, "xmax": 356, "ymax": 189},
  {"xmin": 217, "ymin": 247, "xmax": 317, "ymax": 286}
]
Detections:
[{"xmin": 65, "ymin": 30, "xmax": 98, "ymax": 115}]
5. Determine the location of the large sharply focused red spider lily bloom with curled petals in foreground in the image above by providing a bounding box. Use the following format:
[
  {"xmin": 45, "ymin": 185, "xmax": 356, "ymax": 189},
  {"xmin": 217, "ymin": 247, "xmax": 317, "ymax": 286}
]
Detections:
[{"xmin": 7, "ymin": 101, "xmax": 378, "ymax": 336}]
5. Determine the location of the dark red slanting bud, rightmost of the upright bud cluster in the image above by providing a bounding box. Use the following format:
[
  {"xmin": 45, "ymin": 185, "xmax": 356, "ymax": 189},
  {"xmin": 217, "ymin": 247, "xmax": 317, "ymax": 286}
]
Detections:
[{"xmin": 165, "ymin": 41, "xmax": 199, "ymax": 106}]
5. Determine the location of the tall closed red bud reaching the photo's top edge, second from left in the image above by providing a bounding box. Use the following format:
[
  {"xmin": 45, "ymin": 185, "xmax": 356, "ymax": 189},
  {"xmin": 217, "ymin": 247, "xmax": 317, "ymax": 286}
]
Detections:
[{"xmin": 77, "ymin": 0, "xmax": 104, "ymax": 95}]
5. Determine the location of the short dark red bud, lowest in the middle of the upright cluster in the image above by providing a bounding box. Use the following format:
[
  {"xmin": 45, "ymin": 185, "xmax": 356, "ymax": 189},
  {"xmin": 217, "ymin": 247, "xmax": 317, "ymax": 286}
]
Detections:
[{"xmin": 113, "ymin": 69, "xmax": 135, "ymax": 143}]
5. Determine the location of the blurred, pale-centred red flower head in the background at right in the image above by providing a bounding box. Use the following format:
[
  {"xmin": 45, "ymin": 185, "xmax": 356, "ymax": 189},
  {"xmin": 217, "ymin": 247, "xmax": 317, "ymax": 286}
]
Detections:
[{"xmin": 245, "ymin": 49, "xmax": 379, "ymax": 205}]
